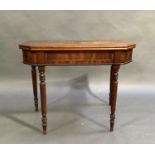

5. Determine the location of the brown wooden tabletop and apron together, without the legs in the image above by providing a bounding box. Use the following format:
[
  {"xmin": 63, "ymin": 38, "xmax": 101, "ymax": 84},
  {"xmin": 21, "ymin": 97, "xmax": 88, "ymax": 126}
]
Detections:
[{"xmin": 19, "ymin": 41, "xmax": 135, "ymax": 65}]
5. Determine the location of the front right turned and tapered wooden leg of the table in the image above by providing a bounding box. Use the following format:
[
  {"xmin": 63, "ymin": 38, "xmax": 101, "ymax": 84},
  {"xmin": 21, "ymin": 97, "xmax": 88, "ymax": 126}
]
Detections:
[{"xmin": 110, "ymin": 65, "xmax": 120, "ymax": 131}]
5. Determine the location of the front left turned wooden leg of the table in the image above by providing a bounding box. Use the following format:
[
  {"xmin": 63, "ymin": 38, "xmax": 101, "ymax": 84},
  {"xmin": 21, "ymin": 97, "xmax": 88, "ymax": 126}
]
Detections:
[{"xmin": 38, "ymin": 66, "xmax": 47, "ymax": 134}]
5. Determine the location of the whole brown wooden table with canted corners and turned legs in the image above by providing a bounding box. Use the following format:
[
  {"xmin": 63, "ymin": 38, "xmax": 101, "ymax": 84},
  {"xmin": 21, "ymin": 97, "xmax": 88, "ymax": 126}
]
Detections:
[{"xmin": 19, "ymin": 41, "xmax": 136, "ymax": 134}]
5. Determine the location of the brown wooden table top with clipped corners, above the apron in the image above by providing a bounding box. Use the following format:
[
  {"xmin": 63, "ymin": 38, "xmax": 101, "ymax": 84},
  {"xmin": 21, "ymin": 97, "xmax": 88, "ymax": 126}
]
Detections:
[{"xmin": 19, "ymin": 40, "xmax": 136, "ymax": 51}]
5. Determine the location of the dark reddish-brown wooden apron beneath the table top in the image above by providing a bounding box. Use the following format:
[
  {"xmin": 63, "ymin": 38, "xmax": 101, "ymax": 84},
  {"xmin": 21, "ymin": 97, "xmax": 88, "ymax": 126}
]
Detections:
[{"xmin": 23, "ymin": 49, "xmax": 132, "ymax": 65}]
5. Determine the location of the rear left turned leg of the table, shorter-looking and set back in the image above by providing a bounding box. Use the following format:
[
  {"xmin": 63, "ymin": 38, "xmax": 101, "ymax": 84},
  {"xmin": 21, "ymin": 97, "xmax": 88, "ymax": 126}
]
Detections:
[{"xmin": 31, "ymin": 66, "xmax": 38, "ymax": 111}]
